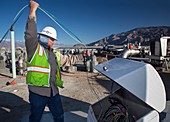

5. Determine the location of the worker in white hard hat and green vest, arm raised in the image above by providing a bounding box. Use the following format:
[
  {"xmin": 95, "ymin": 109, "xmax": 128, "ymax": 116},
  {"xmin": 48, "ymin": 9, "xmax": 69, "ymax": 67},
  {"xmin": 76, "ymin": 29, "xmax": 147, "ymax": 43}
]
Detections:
[{"xmin": 25, "ymin": 0, "xmax": 89, "ymax": 122}]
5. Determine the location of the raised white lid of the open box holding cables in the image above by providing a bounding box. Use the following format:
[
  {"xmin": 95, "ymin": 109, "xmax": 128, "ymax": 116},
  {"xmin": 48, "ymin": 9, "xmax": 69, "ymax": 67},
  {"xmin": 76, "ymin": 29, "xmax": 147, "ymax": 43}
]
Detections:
[{"xmin": 95, "ymin": 58, "xmax": 166, "ymax": 112}]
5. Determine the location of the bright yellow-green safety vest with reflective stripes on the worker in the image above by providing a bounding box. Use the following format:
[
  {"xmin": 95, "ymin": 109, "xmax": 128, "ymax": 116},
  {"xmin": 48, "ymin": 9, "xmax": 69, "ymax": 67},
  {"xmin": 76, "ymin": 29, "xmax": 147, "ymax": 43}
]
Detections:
[{"xmin": 26, "ymin": 44, "xmax": 63, "ymax": 88}]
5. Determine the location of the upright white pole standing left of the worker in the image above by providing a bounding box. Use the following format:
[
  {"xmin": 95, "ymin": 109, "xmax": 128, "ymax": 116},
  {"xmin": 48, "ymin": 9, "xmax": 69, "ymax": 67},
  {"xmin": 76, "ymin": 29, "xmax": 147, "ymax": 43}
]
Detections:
[{"xmin": 10, "ymin": 26, "xmax": 16, "ymax": 78}]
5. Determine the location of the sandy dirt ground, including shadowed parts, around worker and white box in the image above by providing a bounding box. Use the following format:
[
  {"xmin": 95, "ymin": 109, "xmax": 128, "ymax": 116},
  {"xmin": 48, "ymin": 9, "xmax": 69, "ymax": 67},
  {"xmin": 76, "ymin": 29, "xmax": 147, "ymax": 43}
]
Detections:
[{"xmin": 0, "ymin": 69, "xmax": 170, "ymax": 122}]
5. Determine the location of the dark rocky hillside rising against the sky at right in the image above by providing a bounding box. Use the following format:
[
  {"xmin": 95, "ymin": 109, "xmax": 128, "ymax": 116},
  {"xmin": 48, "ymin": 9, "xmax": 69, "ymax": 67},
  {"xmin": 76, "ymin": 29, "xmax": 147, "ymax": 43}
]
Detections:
[{"xmin": 88, "ymin": 26, "xmax": 170, "ymax": 46}]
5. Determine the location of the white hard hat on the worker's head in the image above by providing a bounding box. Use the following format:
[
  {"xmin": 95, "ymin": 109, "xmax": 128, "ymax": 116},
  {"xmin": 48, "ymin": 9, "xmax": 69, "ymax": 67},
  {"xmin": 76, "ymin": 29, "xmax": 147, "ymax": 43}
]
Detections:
[{"xmin": 38, "ymin": 26, "xmax": 57, "ymax": 40}]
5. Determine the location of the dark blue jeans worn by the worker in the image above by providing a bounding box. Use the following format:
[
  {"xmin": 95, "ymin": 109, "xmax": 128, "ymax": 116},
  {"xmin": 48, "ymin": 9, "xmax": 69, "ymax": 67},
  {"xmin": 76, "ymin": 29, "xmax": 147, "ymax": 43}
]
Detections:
[{"xmin": 29, "ymin": 91, "xmax": 64, "ymax": 122}]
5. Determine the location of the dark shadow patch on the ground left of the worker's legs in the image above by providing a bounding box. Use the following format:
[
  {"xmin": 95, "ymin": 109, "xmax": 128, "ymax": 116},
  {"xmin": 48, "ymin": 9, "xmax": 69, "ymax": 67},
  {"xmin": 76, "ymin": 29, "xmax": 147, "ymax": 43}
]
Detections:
[{"xmin": 0, "ymin": 91, "xmax": 29, "ymax": 122}]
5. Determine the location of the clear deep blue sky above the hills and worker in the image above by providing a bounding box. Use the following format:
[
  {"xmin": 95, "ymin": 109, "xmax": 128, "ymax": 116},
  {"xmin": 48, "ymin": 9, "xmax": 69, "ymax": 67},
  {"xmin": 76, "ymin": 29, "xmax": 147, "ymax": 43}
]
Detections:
[{"xmin": 0, "ymin": 0, "xmax": 170, "ymax": 45}]
